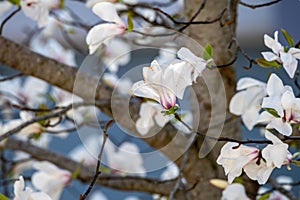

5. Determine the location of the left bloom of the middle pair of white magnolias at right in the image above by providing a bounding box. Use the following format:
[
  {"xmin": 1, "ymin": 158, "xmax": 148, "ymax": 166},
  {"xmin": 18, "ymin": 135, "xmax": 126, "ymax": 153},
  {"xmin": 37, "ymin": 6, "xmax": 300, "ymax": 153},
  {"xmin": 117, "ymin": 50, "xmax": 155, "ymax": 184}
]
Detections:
[{"xmin": 229, "ymin": 77, "xmax": 266, "ymax": 130}]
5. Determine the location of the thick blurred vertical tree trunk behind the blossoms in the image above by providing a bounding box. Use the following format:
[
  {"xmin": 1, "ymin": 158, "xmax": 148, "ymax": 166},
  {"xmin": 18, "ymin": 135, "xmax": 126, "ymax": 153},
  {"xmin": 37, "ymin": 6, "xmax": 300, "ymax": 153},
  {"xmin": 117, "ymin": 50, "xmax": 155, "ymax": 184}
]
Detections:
[{"xmin": 171, "ymin": 0, "xmax": 257, "ymax": 200}]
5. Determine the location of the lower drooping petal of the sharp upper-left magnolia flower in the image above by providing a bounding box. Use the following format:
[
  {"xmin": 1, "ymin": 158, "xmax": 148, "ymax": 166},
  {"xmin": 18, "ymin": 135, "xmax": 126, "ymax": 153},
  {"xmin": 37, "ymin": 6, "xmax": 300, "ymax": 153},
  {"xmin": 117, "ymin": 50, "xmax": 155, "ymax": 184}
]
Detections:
[{"xmin": 86, "ymin": 23, "xmax": 125, "ymax": 54}]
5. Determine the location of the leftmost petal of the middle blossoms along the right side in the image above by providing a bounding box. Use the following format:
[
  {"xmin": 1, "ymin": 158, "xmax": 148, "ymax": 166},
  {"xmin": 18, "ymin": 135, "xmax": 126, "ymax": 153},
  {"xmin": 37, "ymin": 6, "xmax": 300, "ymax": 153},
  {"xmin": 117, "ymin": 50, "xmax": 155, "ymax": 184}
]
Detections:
[{"xmin": 229, "ymin": 91, "xmax": 246, "ymax": 115}]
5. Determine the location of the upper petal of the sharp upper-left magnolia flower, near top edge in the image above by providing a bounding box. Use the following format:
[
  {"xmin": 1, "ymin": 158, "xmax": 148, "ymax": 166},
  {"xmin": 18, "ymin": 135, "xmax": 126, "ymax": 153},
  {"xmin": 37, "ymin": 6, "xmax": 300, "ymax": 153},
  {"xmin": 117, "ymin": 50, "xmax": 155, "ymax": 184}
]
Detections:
[{"xmin": 92, "ymin": 2, "xmax": 126, "ymax": 27}]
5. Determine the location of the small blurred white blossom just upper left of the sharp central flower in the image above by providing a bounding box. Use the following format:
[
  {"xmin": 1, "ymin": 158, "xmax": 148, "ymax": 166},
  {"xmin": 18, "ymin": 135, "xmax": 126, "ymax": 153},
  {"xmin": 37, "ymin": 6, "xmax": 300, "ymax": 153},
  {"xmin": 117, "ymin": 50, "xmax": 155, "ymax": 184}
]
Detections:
[{"xmin": 103, "ymin": 73, "xmax": 132, "ymax": 95}]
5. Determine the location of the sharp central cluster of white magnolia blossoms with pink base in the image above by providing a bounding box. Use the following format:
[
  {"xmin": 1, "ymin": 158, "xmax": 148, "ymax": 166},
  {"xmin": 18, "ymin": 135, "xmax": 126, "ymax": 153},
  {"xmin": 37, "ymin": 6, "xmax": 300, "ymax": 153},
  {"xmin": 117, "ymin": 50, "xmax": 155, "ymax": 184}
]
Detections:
[{"xmin": 131, "ymin": 47, "xmax": 207, "ymax": 135}]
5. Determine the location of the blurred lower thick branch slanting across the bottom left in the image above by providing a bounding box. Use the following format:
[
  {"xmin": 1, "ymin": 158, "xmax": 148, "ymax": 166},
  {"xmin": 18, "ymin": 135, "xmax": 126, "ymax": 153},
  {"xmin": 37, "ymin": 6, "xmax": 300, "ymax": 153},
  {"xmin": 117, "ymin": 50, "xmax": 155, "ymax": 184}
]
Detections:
[{"xmin": 5, "ymin": 138, "xmax": 175, "ymax": 195}]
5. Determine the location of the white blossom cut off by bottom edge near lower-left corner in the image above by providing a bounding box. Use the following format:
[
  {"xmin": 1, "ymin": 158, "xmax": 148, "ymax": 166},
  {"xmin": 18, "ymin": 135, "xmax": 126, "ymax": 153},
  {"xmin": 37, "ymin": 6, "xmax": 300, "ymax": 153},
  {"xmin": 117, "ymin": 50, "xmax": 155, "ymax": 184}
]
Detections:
[{"xmin": 14, "ymin": 176, "xmax": 52, "ymax": 200}]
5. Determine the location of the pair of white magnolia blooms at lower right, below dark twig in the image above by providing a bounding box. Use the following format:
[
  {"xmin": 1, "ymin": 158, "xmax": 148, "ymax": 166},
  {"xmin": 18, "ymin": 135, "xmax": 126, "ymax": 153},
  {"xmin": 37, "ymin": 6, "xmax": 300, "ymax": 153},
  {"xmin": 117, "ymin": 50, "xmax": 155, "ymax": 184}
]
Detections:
[{"xmin": 217, "ymin": 131, "xmax": 291, "ymax": 184}]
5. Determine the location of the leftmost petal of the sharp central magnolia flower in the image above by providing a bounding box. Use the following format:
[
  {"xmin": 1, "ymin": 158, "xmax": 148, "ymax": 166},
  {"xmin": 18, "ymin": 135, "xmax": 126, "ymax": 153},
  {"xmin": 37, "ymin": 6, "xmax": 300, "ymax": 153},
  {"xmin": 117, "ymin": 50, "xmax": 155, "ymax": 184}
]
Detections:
[{"xmin": 131, "ymin": 81, "xmax": 160, "ymax": 102}]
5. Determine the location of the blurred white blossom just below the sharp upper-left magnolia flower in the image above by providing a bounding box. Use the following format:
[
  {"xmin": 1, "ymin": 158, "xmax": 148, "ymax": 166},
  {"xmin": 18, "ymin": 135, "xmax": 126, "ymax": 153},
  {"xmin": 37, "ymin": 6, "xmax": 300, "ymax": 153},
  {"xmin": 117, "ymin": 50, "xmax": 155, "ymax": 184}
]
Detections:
[{"xmin": 101, "ymin": 38, "xmax": 130, "ymax": 73}]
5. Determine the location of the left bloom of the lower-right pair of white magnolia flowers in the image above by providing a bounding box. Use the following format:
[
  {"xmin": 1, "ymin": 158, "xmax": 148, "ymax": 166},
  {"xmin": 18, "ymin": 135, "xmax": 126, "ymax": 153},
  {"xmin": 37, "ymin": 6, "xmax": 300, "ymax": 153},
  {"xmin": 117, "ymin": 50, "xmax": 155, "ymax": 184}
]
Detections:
[{"xmin": 217, "ymin": 142, "xmax": 259, "ymax": 183}]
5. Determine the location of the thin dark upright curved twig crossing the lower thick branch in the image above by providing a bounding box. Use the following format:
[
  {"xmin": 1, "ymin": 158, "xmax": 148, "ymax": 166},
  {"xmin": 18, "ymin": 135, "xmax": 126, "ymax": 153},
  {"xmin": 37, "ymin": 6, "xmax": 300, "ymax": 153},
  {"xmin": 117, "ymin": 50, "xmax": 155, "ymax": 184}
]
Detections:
[{"xmin": 80, "ymin": 120, "xmax": 114, "ymax": 200}]
